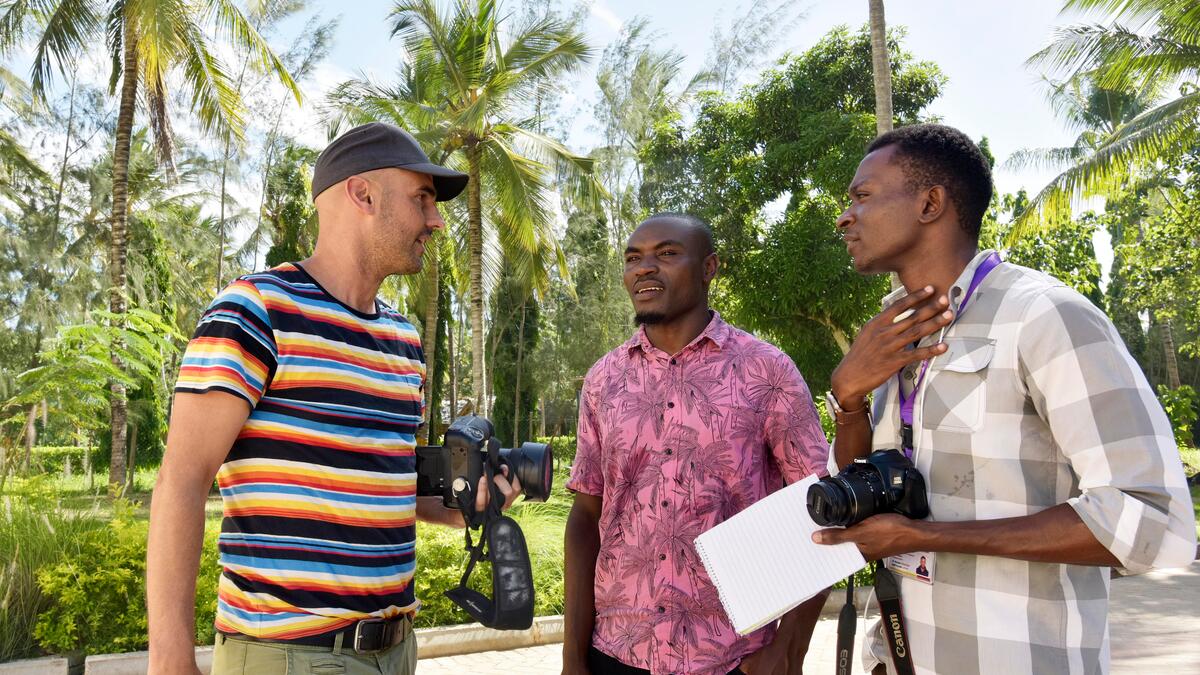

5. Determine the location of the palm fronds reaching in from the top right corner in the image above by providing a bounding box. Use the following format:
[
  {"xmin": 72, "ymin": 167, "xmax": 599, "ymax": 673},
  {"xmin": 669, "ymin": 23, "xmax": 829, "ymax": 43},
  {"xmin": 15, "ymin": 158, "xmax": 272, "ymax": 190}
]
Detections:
[{"xmin": 1013, "ymin": 0, "xmax": 1200, "ymax": 237}]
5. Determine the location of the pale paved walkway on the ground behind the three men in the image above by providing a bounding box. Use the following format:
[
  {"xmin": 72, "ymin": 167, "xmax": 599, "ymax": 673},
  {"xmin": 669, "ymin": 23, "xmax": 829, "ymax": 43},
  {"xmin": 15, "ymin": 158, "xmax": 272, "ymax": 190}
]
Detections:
[{"xmin": 416, "ymin": 562, "xmax": 1200, "ymax": 675}]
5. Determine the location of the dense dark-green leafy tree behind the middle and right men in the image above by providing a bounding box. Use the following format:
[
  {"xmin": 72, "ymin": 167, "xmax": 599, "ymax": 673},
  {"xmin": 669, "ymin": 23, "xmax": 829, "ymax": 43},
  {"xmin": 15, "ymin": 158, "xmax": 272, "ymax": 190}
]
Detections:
[{"xmin": 642, "ymin": 28, "xmax": 944, "ymax": 390}]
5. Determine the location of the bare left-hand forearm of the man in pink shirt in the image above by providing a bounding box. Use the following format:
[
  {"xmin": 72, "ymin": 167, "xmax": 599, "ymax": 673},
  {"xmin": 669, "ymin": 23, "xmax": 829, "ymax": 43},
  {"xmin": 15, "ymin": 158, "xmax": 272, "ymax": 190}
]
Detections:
[{"xmin": 563, "ymin": 499, "xmax": 600, "ymax": 662}]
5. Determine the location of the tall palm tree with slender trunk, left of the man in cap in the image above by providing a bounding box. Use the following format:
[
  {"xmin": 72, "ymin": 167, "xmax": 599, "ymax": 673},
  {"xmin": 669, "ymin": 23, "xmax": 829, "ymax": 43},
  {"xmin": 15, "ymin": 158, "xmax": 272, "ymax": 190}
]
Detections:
[{"xmin": 0, "ymin": 0, "xmax": 300, "ymax": 485}]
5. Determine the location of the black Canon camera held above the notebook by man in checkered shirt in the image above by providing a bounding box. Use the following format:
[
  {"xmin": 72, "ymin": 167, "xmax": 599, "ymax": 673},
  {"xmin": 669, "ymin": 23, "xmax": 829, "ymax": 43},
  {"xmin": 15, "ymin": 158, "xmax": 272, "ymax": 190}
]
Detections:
[{"xmin": 808, "ymin": 449, "xmax": 929, "ymax": 526}]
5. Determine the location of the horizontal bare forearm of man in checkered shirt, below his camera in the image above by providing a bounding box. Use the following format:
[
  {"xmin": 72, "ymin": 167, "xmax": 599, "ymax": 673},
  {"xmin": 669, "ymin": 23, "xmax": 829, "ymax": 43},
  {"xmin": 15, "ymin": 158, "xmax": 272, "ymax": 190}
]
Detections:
[{"xmin": 913, "ymin": 504, "xmax": 1121, "ymax": 567}]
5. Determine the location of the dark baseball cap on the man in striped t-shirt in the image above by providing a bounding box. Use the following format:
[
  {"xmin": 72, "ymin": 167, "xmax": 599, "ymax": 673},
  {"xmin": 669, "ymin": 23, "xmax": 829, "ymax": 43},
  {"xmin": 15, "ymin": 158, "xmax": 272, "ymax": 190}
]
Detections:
[{"xmin": 312, "ymin": 121, "xmax": 467, "ymax": 202}]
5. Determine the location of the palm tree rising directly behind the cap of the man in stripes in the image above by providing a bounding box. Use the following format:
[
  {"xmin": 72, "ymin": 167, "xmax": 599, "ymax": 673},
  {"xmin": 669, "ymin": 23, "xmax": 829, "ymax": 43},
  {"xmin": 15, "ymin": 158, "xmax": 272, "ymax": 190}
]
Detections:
[{"xmin": 332, "ymin": 0, "xmax": 598, "ymax": 413}]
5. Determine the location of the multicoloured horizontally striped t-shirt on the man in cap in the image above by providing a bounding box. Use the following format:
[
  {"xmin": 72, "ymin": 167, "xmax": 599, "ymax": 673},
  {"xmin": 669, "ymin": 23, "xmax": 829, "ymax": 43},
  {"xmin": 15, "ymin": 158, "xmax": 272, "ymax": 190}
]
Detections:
[{"xmin": 175, "ymin": 264, "xmax": 425, "ymax": 639}]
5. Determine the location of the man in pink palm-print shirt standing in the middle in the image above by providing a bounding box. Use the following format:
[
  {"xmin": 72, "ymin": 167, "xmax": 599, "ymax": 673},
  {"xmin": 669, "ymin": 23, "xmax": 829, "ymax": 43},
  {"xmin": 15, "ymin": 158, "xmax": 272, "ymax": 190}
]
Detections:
[{"xmin": 563, "ymin": 214, "xmax": 829, "ymax": 675}]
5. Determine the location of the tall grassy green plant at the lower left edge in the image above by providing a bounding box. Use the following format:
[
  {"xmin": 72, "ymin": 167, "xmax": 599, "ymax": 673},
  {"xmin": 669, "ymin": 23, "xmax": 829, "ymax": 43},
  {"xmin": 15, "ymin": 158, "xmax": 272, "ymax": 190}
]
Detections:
[{"xmin": 0, "ymin": 494, "xmax": 103, "ymax": 662}]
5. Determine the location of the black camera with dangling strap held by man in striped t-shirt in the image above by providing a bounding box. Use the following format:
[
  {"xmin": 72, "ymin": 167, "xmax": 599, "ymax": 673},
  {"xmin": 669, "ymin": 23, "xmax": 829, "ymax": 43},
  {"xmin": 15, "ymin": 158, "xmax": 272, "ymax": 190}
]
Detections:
[{"xmin": 416, "ymin": 416, "xmax": 554, "ymax": 631}]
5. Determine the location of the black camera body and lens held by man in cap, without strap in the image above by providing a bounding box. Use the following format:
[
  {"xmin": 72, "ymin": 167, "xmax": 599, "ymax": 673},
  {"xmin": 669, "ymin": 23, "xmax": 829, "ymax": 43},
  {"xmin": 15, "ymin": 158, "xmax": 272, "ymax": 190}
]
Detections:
[{"xmin": 416, "ymin": 414, "xmax": 554, "ymax": 509}]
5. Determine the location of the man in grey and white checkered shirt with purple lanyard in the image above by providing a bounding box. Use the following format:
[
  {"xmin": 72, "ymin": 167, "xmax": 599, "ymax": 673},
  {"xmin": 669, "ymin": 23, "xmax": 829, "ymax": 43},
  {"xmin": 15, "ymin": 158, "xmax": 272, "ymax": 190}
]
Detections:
[{"xmin": 814, "ymin": 125, "xmax": 1196, "ymax": 675}]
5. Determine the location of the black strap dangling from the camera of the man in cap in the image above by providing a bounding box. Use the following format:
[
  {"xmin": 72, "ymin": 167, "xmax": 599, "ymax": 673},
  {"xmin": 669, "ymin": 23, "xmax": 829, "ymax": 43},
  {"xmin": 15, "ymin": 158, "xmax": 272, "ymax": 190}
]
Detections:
[{"xmin": 445, "ymin": 458, "xmax": 534, "ymax": 631}]
